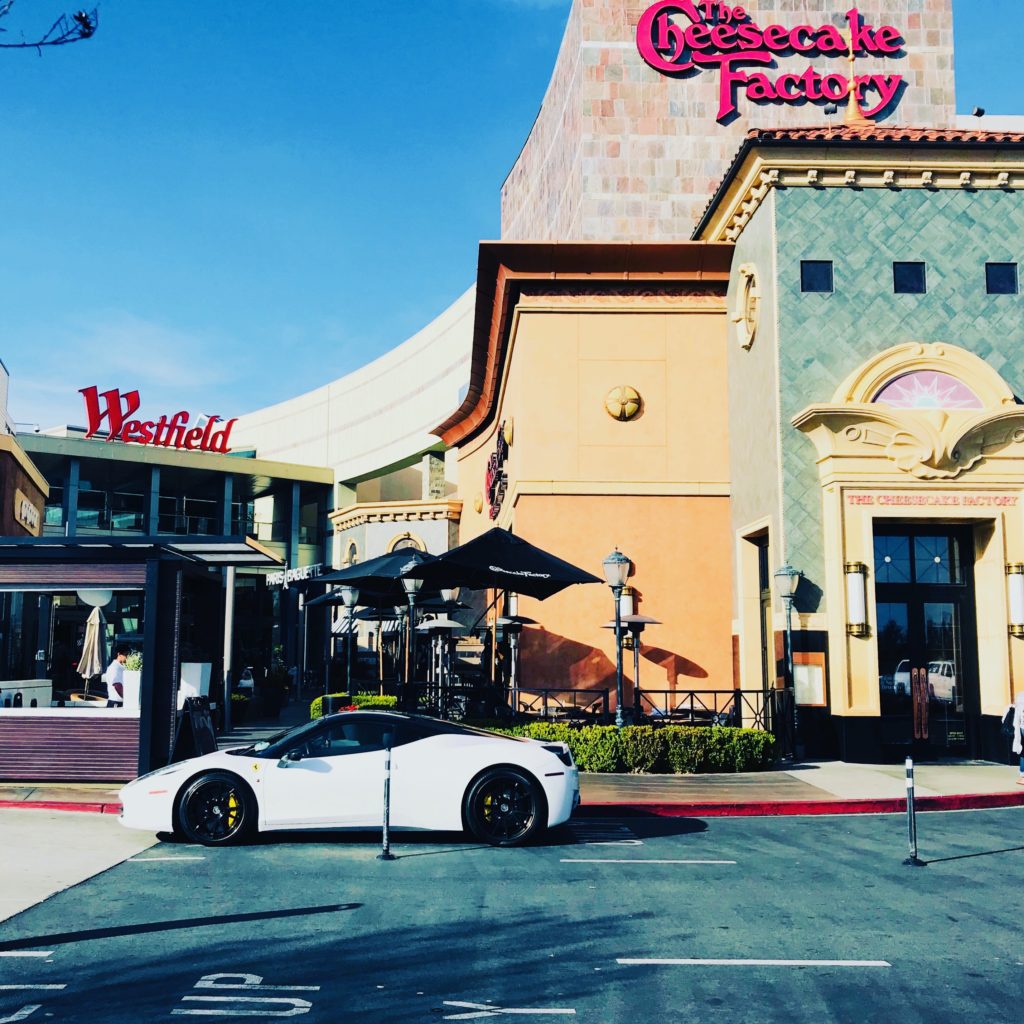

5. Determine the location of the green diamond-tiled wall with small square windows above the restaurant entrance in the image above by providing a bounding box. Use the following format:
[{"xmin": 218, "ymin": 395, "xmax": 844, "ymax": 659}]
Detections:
[{"xmin": 776, "ymin": 188, "xmax": 1024, "ymax": 598}]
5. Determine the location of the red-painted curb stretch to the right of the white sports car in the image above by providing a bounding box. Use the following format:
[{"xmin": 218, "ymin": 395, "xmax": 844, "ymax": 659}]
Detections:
[{"xmin": 575, "ymin": 793, "xmax": 1024, "ymax": 818}]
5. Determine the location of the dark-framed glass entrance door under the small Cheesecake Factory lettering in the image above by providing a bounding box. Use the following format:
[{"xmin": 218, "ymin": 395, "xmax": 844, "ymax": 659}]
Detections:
[{"xmin": 874, "ymin": 525, "xmax": 980, "ymax": 755}]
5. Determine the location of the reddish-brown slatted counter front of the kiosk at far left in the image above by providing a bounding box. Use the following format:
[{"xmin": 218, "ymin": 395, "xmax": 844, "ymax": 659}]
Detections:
[{"xmin": 0, "ymin": 712, "xmax": 139, "ymax": 782}]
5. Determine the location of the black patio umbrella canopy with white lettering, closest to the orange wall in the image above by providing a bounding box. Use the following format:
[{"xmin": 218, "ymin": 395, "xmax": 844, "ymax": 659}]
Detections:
[{"xmin": 402, "ymin": 526, "xmax": 604, "ymax": 601}]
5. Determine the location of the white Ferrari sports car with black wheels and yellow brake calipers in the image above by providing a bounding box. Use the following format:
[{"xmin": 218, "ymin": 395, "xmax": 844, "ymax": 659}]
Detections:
[{"xmin": 121, "ymin": 711, "xmax": 580, "ymax": 846}]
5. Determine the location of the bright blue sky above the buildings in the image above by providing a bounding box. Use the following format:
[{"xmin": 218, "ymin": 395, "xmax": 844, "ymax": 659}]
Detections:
[{"xmin": 0, "ymin": 0, "xmax": 1024, "ymax": 426}]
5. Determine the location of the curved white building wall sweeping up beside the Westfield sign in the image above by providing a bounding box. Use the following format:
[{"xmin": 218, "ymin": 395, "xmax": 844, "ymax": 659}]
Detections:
[{"xmin": 231, "ymin": 288, "xmax": 476, "ymax": 481}]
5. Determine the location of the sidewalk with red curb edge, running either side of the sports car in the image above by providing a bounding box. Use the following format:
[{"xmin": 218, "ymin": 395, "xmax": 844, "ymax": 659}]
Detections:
[{"xmin": 6, "ymin": 761, "xmax": 1024, "ymax": 817}]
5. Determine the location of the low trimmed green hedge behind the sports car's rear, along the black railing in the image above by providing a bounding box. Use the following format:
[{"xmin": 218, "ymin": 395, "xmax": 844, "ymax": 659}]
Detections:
[{"xmin": 479, "ymin": 722, "xmax": 775, "ymax": 775}]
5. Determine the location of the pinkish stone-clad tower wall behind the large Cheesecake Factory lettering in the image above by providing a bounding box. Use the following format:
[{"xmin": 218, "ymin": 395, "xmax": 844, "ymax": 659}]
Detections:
[{"xmin": 502, "ymin": 0, "xmax": 955, "ymax": 241}]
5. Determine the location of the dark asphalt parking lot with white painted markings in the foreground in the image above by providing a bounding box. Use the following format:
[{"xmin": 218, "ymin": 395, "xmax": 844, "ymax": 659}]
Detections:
[{"xmin": 0, "ymin": 809, "xmax": 1024, "ymax": 1024}]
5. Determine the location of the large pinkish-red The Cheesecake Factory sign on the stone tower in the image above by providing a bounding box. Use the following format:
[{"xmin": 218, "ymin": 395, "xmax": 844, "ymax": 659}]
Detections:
[{"xmin": 637, "ymin": 0, "xmax": 904, "ymax": 123}]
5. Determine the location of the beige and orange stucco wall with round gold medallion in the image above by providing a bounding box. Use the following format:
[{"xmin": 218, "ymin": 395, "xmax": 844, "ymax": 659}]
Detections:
[{"xmin": 459, "ymin": 296, "xmax": 732, "ymax": 689}]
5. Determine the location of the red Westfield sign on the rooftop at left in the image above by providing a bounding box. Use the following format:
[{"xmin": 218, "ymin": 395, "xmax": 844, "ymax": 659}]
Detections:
[{"xmin": 80, "ymin": 387, "xmax": 238, "ymax": 455}]
